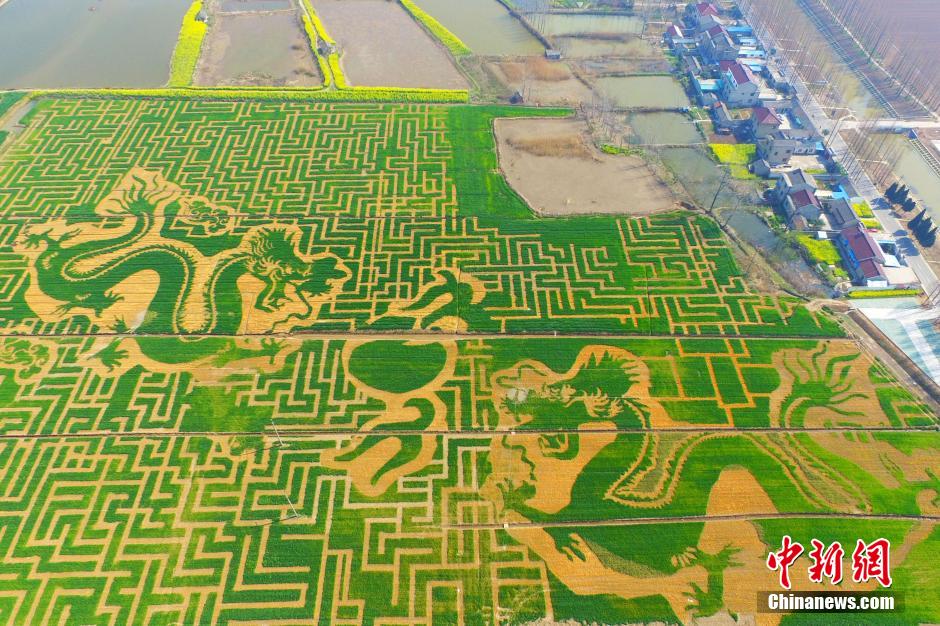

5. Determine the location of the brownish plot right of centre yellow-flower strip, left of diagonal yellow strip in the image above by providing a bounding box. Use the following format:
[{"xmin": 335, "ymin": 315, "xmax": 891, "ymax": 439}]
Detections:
[{"xmin": 313, "ymin": 0, "xmax": 467, "ymax": 89}]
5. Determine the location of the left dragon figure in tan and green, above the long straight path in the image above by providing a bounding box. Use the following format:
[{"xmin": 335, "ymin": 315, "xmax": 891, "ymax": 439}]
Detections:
[{"xmin": 18, "ymin": 170, "xmax": 350, "ymax": 335}]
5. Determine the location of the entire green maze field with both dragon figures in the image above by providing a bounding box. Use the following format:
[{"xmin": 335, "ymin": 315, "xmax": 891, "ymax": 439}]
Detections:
[{"xmin": 0, "ymin": 99, "xmax": 940, "ymax": 626}]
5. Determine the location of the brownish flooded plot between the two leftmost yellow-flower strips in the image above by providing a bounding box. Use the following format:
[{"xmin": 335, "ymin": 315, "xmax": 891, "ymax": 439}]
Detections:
[{"xmin": 195, "ymin": 10, "xmax": 323, "ymax": 87}]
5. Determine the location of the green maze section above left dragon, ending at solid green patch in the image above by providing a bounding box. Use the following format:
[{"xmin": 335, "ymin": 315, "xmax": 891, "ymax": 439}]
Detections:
[{"xmin": 0, "ymin": 100, "xmax": 456, "ymax": 220}]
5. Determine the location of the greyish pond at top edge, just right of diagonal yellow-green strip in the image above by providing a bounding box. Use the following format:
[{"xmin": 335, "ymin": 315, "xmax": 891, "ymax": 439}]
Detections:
[{"xmin": 408, "ymin": 0, "xmax": 545, "ymax": 56}]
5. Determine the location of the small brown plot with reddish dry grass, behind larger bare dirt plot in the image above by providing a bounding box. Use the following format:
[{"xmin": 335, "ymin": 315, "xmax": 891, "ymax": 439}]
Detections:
[{"xmin": 490, "ymin": 59, "xmax": 593, "ymax": 106}]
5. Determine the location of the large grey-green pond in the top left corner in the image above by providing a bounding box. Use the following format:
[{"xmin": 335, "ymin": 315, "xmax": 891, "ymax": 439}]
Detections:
[{"xmin": 0, "ymin": 0, "xmax": 190, "ymax": 88}]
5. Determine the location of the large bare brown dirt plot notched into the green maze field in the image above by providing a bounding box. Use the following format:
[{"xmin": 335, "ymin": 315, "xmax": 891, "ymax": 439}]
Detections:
[{"xmin": 496, "ymin": 119, "xmax": 676, "ymax": 215}]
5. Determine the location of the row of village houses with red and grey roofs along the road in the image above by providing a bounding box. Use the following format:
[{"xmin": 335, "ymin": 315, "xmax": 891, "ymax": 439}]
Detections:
[{"xmin": 665, "ymin": 2, "xmax": 917, "ymax": 289}]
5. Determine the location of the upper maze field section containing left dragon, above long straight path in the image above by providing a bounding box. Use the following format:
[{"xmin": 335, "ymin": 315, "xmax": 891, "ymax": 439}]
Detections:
[{"xmin": 0, "ymin": 100, "xmax": 841, "ymax": 336}]
